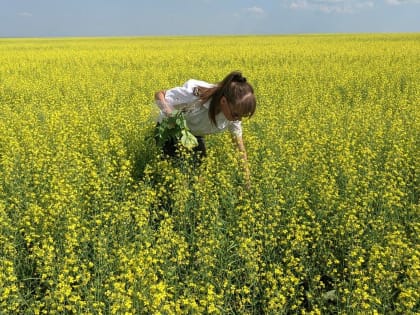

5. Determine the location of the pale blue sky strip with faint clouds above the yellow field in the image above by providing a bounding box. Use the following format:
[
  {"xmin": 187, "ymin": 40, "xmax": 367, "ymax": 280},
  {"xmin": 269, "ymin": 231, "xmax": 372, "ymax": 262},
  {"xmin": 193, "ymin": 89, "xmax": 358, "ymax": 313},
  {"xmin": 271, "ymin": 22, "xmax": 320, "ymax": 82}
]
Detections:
[{"xmin": 0, "ymin": 0, "xmax": 420, "ymax": 37}]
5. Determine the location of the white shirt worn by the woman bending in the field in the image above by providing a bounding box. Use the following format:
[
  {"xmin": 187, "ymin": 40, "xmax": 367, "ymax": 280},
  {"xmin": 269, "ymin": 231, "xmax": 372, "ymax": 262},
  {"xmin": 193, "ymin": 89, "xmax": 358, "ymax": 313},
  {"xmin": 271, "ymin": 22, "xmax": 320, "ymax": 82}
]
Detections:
[{"xmin": 156, "ymin": 79, "xmax": 242, "ymax": 137}]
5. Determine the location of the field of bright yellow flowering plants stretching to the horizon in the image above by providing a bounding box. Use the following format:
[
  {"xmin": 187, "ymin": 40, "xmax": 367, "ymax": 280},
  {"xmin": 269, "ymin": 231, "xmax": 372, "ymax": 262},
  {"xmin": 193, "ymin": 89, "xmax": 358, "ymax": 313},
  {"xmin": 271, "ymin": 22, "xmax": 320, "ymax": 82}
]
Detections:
[{"xmin": 0, "ymin": 34, "xmax": 420, "ymax": 314}]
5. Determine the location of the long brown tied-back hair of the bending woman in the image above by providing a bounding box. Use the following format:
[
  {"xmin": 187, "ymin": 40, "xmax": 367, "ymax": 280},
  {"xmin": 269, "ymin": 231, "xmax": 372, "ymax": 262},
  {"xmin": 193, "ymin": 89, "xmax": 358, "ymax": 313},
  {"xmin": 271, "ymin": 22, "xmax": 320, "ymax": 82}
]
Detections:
[{"xmin": 198, "ymin": 71, "xmax": 256, "ymax": 125}]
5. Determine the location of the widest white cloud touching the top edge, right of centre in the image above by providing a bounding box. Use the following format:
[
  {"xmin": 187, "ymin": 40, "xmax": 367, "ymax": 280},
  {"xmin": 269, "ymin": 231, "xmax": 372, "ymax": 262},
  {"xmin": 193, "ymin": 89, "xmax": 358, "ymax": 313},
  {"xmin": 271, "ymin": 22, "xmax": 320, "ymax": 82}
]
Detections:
[{"xmin": 285, "ymin": 0, "xmax": 376, "ymax": 13}]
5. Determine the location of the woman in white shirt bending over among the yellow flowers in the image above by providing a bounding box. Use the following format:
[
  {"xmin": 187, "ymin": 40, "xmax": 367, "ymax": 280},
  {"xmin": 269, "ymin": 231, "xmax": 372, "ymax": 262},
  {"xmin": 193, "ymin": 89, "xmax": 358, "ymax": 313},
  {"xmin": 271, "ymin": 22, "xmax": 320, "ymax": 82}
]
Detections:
[{"xmin": 155, "ymin": 71, "xmax": 256, "ymax": 184}]
